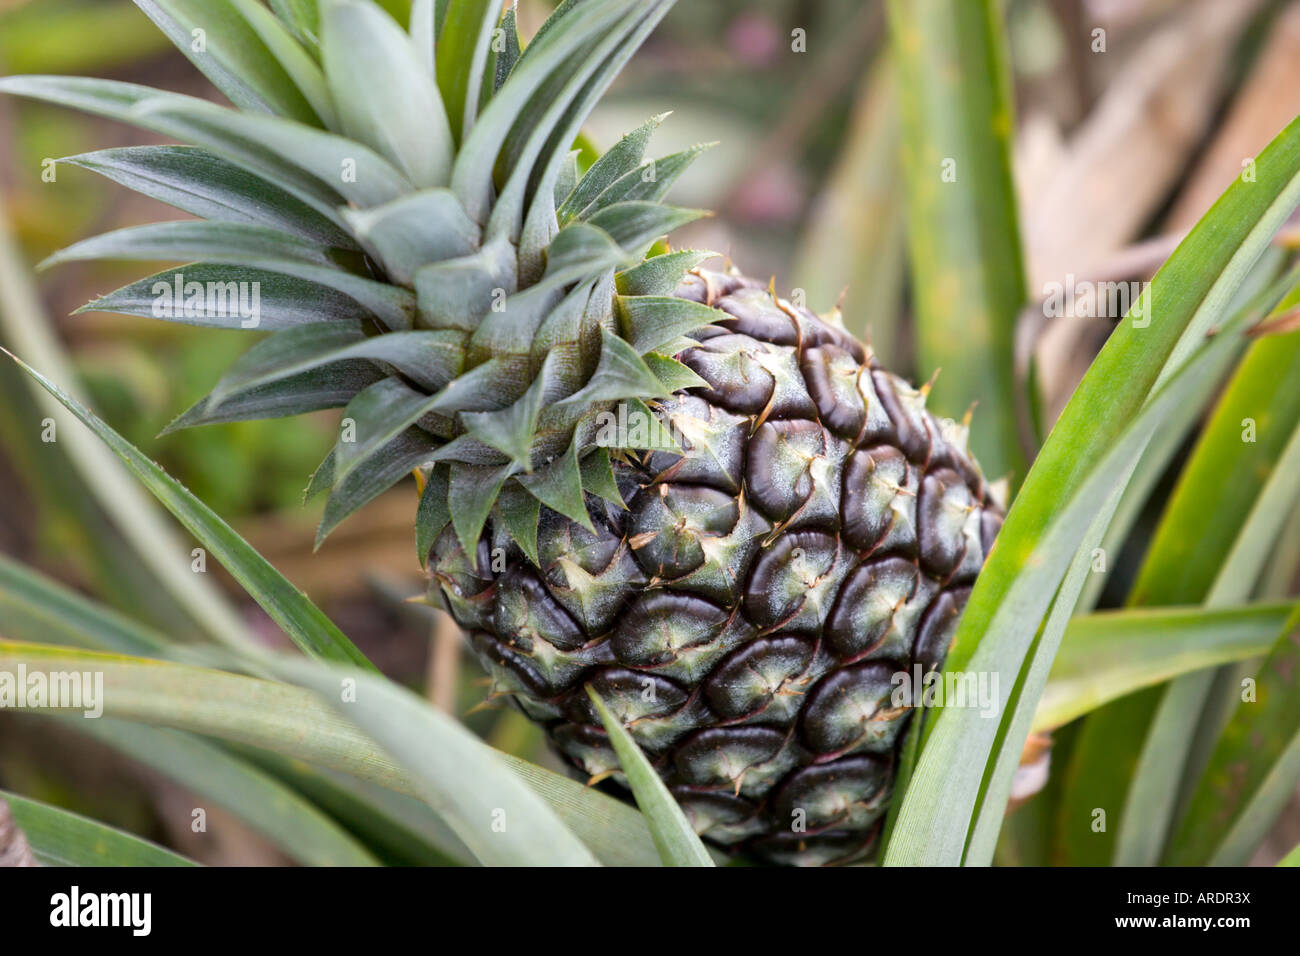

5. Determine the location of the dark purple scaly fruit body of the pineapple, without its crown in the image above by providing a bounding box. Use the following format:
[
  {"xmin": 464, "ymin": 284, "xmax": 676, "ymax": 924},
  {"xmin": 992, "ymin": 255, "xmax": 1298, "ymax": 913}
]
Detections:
[{"xmin": 430, "ymin": 269, "xmax": 1001, "ymax": 865}]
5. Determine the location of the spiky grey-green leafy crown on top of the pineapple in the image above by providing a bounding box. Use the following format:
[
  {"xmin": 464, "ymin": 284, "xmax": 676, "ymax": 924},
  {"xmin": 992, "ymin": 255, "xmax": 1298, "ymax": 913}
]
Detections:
[{"xmin": 0, "ymin": 0, "xmax": 719, "ymax": 562}]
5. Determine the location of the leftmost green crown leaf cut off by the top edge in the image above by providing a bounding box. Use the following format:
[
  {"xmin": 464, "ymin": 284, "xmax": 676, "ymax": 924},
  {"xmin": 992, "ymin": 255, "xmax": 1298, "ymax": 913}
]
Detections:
[{"xmin": 135, "ymin": 0, "xmax": 321, "ymax": 125}]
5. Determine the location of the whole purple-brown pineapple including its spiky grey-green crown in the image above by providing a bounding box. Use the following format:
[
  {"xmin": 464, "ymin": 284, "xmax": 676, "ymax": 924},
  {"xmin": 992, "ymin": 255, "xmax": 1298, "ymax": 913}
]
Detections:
[{"xmin": 0, "ymin": 0, "xmax": 1001, "ymax": 864}]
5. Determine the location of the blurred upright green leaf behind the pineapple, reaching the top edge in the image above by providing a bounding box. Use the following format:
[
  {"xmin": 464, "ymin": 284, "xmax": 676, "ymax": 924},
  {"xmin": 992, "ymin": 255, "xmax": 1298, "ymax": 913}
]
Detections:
[{"xmin": 894, "ymin": 0, "xmax": 1024, "ymax": 484}]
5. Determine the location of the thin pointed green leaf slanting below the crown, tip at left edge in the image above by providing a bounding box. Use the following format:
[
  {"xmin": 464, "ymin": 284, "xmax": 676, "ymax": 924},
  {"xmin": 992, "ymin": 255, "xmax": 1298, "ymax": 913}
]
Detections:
[{"xmin": 7, "ymin": 359, "xmax": 373, "ymax": 670}]
